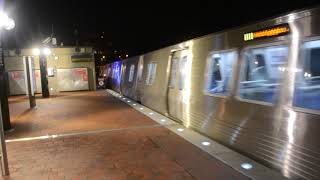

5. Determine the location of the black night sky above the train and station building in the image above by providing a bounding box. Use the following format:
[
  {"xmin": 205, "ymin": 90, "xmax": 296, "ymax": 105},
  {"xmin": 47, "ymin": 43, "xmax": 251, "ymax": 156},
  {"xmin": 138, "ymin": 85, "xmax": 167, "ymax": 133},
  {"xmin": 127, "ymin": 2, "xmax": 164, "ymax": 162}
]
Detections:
[{"xmin": 1, "ymin": 0, "xmax": 320, "ymax": 55}]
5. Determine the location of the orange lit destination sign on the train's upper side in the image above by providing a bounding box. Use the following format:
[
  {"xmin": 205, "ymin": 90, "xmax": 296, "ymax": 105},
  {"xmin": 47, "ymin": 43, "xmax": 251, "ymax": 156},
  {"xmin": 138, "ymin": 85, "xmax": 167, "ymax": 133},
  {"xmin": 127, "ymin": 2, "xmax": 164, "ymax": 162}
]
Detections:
[{"xmin": 243, "ymin": 24, "xmax": 290, "ymax": 41}]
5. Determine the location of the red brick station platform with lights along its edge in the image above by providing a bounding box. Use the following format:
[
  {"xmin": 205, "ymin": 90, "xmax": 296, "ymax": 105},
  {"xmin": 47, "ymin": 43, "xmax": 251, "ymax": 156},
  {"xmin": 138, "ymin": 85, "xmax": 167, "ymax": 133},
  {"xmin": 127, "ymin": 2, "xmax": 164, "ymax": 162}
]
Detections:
[{"xmin": 2, "ymin": 90, "xmax": 284, "ymax": 180}]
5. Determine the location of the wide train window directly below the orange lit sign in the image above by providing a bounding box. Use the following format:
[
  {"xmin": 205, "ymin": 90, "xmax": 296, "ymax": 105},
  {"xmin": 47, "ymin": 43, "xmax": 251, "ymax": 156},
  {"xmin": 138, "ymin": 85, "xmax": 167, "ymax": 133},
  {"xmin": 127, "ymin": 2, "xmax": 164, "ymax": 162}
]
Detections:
[{"xmin": 238, "ymin": 46, "xmax": 288, "ymax": 103}]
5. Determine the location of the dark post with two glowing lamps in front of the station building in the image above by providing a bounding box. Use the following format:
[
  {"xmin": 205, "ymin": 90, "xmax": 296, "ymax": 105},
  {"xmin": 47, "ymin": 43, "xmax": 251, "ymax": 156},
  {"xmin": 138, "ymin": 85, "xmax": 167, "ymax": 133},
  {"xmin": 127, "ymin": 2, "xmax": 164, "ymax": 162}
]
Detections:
[{"xmin": 33, "ymin": 47, "xmax": 51, "ymax": 98}]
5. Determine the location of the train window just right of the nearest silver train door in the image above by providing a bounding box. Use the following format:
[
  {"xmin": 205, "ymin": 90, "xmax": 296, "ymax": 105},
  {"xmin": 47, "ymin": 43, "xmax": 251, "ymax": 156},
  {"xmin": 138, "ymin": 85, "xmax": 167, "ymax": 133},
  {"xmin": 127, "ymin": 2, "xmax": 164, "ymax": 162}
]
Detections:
[{"xmin": 205, "ymin": 51, "xmax": 237, "ymax": 95}]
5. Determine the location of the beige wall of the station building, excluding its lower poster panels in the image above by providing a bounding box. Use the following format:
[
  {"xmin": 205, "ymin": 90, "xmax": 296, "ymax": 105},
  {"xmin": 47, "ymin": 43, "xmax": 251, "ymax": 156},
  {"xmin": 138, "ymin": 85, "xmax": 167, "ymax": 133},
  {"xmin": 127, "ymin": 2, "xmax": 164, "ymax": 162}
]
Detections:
[{"xmin": 5, "ymin": 47, "xmax": 96, "ymax": 94}]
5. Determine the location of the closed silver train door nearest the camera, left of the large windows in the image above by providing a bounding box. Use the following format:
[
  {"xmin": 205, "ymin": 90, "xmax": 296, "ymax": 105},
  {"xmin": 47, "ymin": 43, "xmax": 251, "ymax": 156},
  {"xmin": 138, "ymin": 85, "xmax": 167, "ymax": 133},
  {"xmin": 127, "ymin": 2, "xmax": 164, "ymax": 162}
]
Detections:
[{"xmin": 167, "ymin": 50, "xmax": 188, "ymax": 121}]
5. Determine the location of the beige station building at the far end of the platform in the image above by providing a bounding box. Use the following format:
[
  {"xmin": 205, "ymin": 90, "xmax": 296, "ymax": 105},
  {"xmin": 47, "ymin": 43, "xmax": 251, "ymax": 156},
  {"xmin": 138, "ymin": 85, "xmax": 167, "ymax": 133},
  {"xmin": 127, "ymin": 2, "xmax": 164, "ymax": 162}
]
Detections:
[{"xmin": 4, "ymin": 46, "xmax": 96, "ymax": 95}]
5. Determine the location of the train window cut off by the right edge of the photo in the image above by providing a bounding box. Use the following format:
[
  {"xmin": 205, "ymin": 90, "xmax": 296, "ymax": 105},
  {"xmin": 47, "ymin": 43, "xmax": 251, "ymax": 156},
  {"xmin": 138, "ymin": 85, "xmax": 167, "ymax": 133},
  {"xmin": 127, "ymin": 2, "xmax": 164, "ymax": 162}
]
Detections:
[{"xmin": 293, "ymin": 40, "xmax": 320, "ymax": 110}]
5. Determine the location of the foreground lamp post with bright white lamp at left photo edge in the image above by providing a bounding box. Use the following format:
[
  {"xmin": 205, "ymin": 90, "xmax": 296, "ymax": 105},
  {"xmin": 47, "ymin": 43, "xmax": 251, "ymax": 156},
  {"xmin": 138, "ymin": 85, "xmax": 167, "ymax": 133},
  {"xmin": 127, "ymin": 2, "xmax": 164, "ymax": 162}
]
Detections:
[{"xmin": 0, "ymin": 12, "xmax": 15, "ymax": 176}]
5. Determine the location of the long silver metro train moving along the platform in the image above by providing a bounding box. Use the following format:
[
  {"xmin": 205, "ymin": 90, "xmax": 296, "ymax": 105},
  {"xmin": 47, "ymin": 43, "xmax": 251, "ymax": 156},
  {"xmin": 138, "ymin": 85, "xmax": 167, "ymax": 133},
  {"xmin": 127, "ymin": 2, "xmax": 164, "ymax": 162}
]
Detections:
[{"xmin": 108, "ymin": 7, "xmax": 320, "ymax": 179}]
